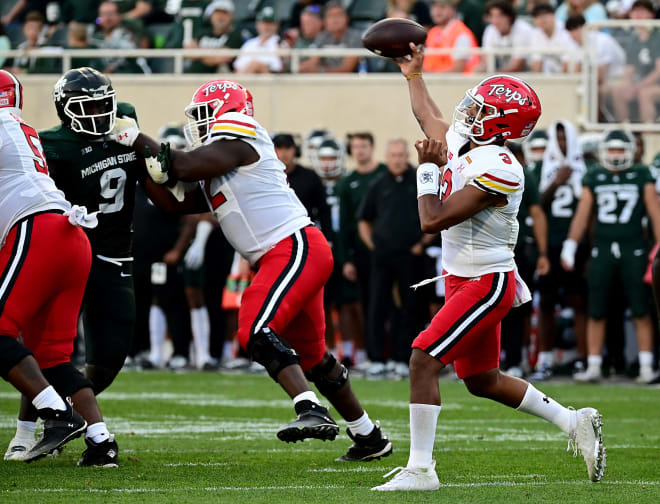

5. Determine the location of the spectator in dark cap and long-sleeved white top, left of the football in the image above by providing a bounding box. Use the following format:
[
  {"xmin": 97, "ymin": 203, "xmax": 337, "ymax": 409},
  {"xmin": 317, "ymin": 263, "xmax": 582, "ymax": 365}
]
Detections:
[{"xmin": 234, "ymin": 6, "xmax": 282, "ymax": 74}]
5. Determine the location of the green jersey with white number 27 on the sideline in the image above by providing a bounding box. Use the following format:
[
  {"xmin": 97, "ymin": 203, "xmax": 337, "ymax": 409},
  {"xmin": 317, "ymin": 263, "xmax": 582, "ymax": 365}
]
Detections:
[{"xmin": 582, "ymin": 165, "xmax": 654, "ymax": 244}]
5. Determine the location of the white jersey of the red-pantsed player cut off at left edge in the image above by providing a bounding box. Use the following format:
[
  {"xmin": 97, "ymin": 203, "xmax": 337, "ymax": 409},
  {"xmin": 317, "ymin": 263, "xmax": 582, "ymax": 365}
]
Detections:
[{"xmin": 0, "ymin": 108, "xmax": 71, "ymax": 246}]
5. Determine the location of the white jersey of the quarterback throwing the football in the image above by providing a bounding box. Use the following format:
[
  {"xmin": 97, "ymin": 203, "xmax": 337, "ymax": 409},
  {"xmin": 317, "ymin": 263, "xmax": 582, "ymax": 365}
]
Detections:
[{"xmin": 441, "ymin": 128, "xmax": 525, "ymax": 277}]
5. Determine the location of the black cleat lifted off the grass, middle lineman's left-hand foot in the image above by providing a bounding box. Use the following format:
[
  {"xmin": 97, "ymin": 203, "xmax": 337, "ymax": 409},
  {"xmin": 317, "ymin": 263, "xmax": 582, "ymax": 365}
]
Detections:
[{"xmin": 277, "ymin": 401, "xmax": 339, "ymax": 443}]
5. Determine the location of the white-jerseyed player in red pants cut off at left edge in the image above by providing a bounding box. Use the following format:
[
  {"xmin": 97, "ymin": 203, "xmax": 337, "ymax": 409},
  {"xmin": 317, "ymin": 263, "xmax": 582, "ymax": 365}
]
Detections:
[{"xmin": 0, "ymin": 70, "xmax": 117, "ymax": 466}]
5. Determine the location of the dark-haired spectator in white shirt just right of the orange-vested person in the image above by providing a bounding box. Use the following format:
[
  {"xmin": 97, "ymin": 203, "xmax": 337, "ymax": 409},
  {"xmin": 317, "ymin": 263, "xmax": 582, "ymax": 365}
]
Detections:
[{"xmin": 480, "ymin": 0, "xmax": 534, "ymax": 73}]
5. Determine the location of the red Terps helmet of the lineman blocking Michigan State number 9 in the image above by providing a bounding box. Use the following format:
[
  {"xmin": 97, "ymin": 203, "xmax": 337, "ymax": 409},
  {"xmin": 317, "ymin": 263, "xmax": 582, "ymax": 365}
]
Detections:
[{"xmin": 184, "ymin": 80, "xmax": 254, "ymax": 146}]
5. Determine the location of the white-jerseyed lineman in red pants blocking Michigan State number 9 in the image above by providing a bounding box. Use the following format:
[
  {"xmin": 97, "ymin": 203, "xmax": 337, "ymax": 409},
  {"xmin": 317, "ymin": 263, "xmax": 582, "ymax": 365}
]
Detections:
[{"xmin": 112, "ymin": 80, "xmax": 392, "ymax": 460}]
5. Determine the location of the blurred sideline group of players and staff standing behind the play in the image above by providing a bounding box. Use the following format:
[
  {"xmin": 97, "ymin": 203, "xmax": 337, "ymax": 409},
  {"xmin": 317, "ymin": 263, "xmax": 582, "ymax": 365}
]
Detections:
[{"xmin": 111, "ymin": 121, "xmax": 660, "ymax": 383}]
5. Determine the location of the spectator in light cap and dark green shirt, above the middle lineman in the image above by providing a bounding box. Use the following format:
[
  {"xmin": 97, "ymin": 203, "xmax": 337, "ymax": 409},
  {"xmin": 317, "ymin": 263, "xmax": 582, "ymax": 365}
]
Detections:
[{"xmin": 184, "ymin": 0, "xmax": 243, "ymax": 73}]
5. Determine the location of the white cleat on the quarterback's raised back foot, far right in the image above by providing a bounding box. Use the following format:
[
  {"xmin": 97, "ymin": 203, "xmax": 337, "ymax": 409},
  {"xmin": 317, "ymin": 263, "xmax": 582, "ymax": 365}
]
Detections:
[{"xmin": 568, "ymin": 408, "xmax": 607, "ymax": 482}]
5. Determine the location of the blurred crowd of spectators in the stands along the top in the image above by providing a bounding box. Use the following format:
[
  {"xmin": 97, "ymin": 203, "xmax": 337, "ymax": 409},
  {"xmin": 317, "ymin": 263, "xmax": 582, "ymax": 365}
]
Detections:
[{"xmin": 0, "ymin": 0, "xmax": 660, "ymax": 122}]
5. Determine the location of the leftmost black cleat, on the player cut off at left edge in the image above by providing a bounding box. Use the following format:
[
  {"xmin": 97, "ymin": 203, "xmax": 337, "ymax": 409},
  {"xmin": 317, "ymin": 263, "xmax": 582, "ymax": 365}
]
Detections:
[{"xmin": 25, "ymin": 397, "xmax": 87, "ymax": 462}]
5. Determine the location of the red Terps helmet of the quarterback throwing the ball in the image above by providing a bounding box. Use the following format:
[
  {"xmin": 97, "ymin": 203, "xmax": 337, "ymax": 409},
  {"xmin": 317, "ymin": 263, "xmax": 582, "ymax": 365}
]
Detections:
[{"xmin": 454, "ymin": 75, "xmax": 541, "ymax": 145}]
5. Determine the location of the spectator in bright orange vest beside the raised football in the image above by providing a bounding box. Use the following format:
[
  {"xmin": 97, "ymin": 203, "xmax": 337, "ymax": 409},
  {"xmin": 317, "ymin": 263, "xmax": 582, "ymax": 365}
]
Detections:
[{"xmin": 424, "ymin": 0, "xmax": 480, "ymax": 73}]
